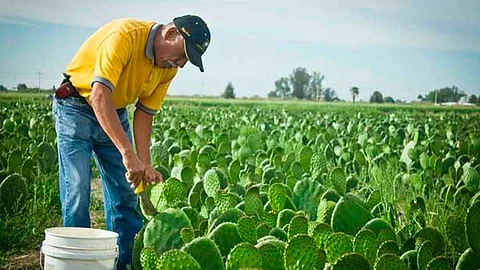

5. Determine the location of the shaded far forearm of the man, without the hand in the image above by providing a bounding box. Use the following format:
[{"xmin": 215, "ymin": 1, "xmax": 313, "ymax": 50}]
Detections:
[{"xmin": 133, "ymin": 109, "xmax": 153, "ymax": 165}]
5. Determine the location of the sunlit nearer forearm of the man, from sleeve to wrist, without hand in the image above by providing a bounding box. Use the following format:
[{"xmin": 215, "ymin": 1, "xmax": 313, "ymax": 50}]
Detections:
[{"xmin": 89, "ymin": 83, "xmax": 135, "ymax": 157}]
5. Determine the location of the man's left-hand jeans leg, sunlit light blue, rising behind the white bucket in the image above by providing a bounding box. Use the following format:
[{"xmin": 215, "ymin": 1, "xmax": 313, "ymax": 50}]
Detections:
[{"xmin": 53, "ymin": 99, "xmax": 93, "ymax": 227}]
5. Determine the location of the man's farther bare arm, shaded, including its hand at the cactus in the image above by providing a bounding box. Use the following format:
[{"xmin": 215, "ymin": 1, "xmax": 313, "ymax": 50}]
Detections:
[{"xmin": 133, "ymin": 108, "xmax": 163, "ymax": 182}]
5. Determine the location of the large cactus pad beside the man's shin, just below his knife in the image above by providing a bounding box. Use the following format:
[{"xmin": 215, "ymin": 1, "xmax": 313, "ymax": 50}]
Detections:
[{"xmin": 143, "ymin": 208, "xmax": 193, "ymax": 254}]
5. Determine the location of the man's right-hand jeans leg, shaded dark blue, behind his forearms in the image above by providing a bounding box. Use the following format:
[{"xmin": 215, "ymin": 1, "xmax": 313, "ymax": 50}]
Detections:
[{"xmin": 93, "ymin": 110, "xmax": 142, "ymax": 269}]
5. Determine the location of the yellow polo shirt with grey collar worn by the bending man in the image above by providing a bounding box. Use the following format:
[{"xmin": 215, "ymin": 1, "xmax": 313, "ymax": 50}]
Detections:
[{"xmin": 65, "ymin": 19, "xmax": 177, "ymax": 114}]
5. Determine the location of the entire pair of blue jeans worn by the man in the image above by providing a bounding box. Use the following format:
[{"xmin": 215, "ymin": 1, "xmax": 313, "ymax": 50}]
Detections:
[{"xmin": 53, "ymin": 97, "xmax": 142, "ymax": 269}]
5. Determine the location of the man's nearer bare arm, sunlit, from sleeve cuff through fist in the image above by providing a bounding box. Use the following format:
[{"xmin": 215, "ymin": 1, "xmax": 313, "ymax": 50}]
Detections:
[{"xmin": 89, "ymin": 82, "xmax": 146, "ymax": 187}]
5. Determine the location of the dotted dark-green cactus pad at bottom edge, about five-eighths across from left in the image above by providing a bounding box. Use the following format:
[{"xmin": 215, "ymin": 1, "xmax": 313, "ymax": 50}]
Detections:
[{"xmin": 284, "ymin": 235, "xmax": 319, "ymax": 270}]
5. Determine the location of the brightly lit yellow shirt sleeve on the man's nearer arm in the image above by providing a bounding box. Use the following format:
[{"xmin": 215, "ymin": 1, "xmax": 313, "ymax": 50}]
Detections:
[{"xmin": 91, "ymin": 33, "xmax": 132, "ymax": 91}]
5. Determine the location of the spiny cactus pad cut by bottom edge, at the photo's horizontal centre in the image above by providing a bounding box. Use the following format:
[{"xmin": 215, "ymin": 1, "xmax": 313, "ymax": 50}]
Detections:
[{"xmin": 226, "ymin": 243, "xmax": 262, "ymax": 270}]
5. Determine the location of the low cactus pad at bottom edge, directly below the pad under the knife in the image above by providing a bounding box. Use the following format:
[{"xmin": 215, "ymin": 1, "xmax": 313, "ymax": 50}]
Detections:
[{"xmin": 158, "ymin": 249, "xmax": 202, "ymax": 270}]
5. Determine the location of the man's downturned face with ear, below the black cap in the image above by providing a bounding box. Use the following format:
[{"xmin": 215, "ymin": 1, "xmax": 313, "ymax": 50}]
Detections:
[{"xmin": 155, "ymin": 29, "xmax": 188, "ymax": 68}]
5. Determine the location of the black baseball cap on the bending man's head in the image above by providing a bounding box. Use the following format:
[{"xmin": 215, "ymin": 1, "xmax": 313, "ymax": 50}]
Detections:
[{"xmin": 173, "ymin": 15, "xmax": 210, "ymax": 72}]
